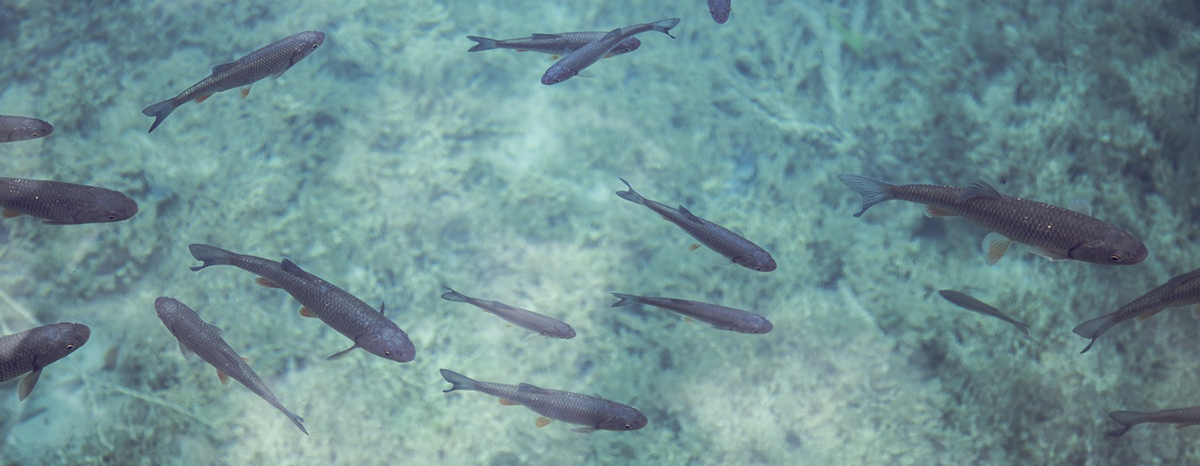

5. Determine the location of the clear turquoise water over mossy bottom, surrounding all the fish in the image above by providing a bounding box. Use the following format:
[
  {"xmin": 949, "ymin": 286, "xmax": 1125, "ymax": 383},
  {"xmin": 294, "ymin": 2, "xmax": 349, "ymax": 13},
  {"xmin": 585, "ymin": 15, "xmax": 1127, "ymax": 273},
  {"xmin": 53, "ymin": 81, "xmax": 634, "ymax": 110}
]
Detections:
[{"xmin": 0, "ymin": 0, "xmax": 1200, "ymax": 466}]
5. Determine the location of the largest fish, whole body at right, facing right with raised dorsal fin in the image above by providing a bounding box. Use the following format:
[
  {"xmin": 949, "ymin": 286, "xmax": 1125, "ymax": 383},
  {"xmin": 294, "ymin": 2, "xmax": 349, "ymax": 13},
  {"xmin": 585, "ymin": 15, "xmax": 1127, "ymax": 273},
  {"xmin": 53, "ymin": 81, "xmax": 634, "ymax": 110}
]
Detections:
[{"xmin": 838, "ymin": 174, "xmax": 1150, "ymax": 265}]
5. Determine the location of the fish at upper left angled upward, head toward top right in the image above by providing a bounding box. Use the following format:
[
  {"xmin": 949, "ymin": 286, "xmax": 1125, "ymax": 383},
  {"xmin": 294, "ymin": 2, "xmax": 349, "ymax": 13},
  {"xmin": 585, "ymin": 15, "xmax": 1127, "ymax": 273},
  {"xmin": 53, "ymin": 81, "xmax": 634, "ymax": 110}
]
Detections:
[{"xmin": 142, "ymin": 31, "xmax": 325, "ymax": 132}]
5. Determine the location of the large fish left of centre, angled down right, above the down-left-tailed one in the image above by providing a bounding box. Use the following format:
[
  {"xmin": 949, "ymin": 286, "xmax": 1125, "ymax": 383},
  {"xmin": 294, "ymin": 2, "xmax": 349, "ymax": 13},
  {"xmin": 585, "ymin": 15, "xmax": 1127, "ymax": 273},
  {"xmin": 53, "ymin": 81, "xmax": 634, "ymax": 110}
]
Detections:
[{"xmin": 187, "ymin": 244, "xmax": 416, "ymax": 363}]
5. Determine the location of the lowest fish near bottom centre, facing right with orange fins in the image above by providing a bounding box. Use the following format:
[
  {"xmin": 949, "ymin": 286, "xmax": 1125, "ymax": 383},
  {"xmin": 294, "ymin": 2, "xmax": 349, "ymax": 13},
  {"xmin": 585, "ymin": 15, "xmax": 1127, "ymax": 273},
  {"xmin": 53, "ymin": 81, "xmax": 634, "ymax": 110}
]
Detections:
[{"xmin": 439, "ymin": 369, "xmax": 649, "ymax": 434}]
